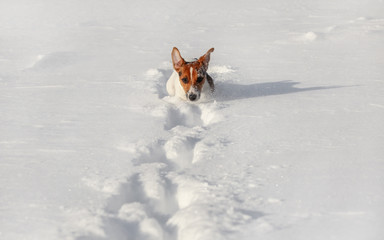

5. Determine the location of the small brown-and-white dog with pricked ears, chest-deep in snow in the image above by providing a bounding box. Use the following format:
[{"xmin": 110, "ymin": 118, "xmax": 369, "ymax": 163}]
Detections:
[{"xmin": 167, "ymin": 47, "xmax": 215, "ymax": 102}]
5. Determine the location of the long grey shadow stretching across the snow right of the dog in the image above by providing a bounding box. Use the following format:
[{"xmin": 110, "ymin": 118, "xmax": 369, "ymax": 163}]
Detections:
[{"xmin": 215, "ymin": 80, "xmax": 343, "ymax": 102}]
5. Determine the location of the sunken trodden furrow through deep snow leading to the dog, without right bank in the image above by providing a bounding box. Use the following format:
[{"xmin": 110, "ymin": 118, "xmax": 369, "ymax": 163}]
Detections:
[{"xmin": 73, "ymin": 65, "xmax": 225, "ymax": 240}]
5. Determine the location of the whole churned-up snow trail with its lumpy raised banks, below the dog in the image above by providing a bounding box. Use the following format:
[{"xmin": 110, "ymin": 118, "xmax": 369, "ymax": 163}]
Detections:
[{"xmin": 77, "ymin": 68, "xmax": 251, "ymax": 240}]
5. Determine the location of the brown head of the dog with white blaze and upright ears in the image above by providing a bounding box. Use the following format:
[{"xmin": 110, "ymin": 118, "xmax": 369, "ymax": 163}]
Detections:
[{"xmin": 172, "ymin": 47, "xmax": 214, "ymax": 101}]
